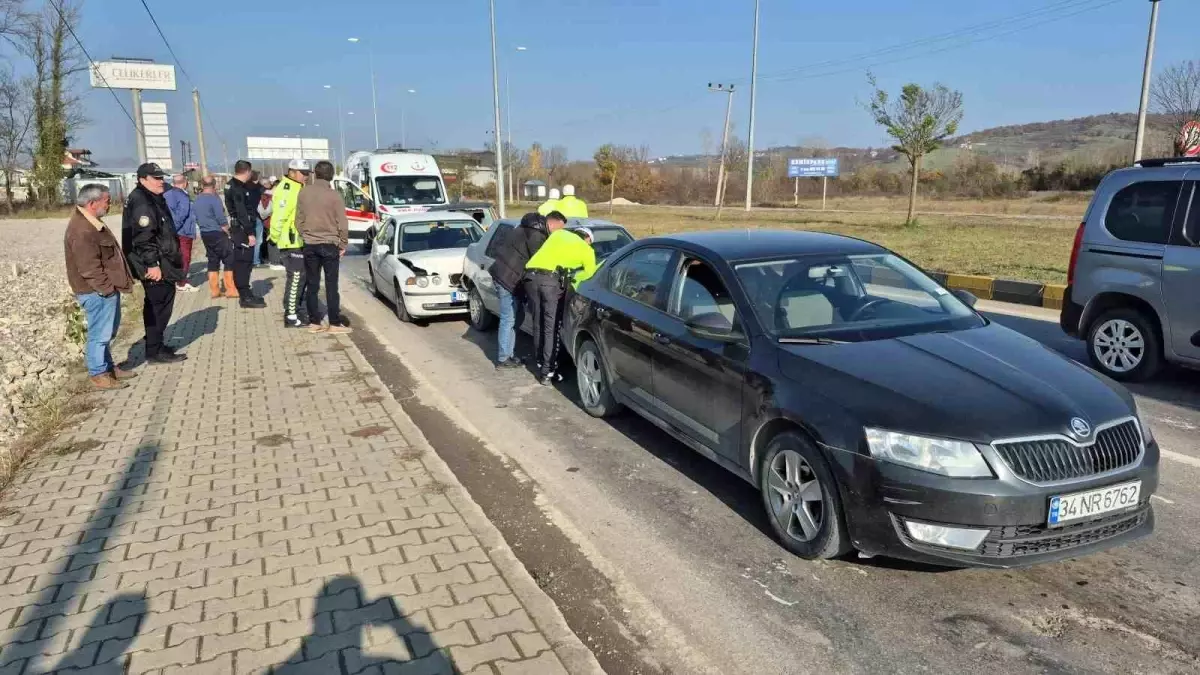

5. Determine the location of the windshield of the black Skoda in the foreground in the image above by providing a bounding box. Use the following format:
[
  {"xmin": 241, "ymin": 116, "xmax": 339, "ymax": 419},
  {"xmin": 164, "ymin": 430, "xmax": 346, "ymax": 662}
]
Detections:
[{"xmin": 734, "ymin": 253, "xmax": 984, "ymax": 341}]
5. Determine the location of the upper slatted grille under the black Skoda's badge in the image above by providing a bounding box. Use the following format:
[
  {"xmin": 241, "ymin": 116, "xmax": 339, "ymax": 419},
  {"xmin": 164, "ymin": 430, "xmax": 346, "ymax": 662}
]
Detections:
[{"xmin": 992, "ymin": 419, "xmax": 1141, "ymax": 483}]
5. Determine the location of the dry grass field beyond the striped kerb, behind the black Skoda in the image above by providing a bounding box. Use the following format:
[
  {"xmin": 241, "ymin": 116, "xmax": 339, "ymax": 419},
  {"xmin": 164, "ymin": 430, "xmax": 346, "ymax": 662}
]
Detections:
[{"xmin": 561, "ymin": 196, "xmax": 1087, "ymax": 283}]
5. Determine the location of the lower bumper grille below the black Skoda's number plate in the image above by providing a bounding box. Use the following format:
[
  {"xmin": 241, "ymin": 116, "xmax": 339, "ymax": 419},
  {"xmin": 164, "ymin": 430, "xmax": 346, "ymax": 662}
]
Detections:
[{"xmin": 978, "ymin": 501, "xmax": 1150, "ymax": 557}]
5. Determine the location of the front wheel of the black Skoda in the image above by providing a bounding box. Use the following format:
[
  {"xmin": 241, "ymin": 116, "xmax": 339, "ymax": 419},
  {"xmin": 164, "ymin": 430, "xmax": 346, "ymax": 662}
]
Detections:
[{"xmin": 758, "ymin": 431, "xmax": 851, "ymax": 560}]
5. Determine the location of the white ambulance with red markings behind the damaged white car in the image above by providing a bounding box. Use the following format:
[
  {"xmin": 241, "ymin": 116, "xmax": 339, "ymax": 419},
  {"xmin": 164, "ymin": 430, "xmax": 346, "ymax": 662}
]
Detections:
[{"xmin": 334, "ymin": 151, "xmax": 449, "ymax": 249}]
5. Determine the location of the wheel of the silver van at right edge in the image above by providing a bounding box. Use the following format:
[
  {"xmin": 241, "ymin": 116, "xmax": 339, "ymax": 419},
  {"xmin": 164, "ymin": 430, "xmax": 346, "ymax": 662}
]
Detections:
[{"xmin": 1087, "ymin": 307, "xmax": 1163, "ymax": 382}]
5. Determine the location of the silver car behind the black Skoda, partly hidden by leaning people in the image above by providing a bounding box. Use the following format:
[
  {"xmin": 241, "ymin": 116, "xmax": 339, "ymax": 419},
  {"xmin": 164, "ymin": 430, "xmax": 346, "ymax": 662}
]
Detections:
[{"xmin": 462, "ymin": 219, "xmax": 634, "ymax": 333}]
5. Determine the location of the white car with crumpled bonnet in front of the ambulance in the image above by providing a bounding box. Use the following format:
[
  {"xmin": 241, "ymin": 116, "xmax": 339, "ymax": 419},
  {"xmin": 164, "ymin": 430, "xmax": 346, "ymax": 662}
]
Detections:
[{"xmin": 367, "ymin": 211, "xmax": 484, "ymax": 322}]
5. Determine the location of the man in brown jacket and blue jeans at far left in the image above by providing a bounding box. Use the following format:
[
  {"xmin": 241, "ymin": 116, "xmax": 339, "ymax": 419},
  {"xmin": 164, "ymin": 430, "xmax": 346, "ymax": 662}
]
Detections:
[{"xmin": 62, "ymin": 185, "xmax": 136, "ymax": 389}]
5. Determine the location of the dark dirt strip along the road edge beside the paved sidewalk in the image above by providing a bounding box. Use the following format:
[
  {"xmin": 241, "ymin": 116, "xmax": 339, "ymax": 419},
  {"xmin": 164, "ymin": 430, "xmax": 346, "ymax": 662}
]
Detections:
[{"xmin": 350, "ymin": 317, "xmax": 672, "ymax": 675}]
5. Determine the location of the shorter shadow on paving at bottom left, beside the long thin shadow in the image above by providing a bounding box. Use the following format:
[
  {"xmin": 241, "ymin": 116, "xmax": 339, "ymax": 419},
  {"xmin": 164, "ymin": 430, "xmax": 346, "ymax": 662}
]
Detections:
[{"xmin": 30, "ymin": 592, "xmax": 148, "ymax": 675}]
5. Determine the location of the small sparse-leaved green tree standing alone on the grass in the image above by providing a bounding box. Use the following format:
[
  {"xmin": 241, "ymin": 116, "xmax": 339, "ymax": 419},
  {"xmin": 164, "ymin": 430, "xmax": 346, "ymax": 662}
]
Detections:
[{"xmin": 866, "ymin": 74, "xmax": 962, "ymax": 225}]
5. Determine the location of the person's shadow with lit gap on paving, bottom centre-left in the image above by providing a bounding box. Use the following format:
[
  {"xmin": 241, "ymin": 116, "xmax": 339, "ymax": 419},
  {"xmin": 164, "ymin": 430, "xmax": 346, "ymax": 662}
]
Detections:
[{"xmin": 272, "ymin": 574, "xmax": 461, "ymax": 675}]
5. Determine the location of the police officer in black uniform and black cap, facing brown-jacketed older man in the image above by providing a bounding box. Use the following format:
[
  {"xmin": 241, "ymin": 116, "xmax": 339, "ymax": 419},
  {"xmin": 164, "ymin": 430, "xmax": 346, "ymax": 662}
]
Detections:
[{"xmin": 121, "ymin": 162, "xmax": 187, "ymax": 363}]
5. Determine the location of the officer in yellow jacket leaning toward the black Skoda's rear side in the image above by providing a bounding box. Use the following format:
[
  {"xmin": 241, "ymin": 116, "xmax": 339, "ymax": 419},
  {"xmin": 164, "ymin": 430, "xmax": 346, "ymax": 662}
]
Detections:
[{"xmin": 524, "ymin": 211, "xmax": 596, "ymax": 384}]
